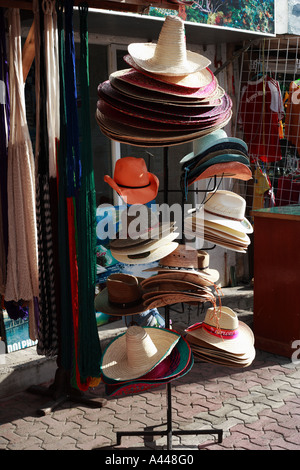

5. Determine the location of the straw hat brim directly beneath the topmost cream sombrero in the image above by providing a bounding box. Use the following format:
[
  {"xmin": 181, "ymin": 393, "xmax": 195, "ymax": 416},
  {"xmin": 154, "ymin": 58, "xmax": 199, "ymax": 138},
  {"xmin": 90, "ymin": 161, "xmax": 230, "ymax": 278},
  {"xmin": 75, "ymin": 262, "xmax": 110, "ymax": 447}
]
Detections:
[{"xmin": 123, "ymin": 54, "xmax": 215, "ymax": 92}]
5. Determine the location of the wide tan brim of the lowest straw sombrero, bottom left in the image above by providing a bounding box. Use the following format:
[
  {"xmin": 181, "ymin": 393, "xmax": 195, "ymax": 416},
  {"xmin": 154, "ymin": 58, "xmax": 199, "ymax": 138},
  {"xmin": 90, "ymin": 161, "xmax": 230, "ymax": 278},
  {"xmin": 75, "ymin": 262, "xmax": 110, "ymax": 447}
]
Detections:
[{"xmin": 100, "ymin": 326, "xmax": 180, "ymax": 381}]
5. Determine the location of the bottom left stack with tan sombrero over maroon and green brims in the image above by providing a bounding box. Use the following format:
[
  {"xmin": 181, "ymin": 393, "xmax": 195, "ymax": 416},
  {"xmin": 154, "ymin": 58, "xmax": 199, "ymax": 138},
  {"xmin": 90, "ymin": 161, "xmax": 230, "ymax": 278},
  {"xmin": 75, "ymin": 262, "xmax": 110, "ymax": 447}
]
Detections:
[{"xmin": 101, "ymin": 325, "xmax": 194, "ymax": 396}]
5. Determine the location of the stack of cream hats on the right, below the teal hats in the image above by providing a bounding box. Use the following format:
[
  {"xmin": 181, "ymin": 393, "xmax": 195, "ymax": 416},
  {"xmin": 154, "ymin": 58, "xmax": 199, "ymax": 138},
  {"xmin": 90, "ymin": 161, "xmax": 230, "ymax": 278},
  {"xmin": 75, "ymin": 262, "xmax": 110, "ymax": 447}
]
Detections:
[{"xmin": 184, "ymin": 190, "xmax": 253, "ymax": 253}]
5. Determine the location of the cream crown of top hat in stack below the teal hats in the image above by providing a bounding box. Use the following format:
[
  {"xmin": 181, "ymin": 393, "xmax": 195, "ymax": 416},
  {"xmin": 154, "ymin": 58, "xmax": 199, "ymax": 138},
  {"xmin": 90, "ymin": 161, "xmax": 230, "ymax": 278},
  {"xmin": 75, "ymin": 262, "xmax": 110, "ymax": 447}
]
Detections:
[{"xmin": 204, "ymin": 190, "xmax": 246, "ymax": 221}]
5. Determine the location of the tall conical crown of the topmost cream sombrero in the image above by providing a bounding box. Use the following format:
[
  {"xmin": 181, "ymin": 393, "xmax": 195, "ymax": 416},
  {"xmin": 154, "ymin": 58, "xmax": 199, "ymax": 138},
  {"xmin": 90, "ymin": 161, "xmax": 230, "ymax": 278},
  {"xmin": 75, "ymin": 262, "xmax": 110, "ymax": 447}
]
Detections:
[{"xmin": 154, "ymin": 16, "xmax": 187, "ymax": 67}]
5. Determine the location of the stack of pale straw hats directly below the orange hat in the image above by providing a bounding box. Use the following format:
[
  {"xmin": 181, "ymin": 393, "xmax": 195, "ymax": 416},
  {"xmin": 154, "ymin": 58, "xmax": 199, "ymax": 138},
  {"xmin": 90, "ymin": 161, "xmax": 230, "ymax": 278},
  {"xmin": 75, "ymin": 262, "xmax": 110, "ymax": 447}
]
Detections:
[{"xmin": 109, "ymin": 204, "xmax": 179, "ymax": 264}]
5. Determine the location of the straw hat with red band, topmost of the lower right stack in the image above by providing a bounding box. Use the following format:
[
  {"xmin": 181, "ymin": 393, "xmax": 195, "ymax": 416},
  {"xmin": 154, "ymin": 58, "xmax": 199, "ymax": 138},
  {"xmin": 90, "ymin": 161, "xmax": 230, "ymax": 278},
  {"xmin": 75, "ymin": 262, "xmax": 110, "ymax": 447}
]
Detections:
[{"xmin": 186, "ymin": 306, "xmax": 254, "ymax": 354}]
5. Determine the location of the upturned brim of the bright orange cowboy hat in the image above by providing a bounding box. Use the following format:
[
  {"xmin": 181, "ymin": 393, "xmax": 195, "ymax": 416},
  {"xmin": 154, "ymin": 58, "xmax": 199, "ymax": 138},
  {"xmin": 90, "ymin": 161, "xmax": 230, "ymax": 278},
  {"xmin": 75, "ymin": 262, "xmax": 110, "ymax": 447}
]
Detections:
[{"xmin": 104, "ymin": 172, "xmax": 159, "ymax": 204}]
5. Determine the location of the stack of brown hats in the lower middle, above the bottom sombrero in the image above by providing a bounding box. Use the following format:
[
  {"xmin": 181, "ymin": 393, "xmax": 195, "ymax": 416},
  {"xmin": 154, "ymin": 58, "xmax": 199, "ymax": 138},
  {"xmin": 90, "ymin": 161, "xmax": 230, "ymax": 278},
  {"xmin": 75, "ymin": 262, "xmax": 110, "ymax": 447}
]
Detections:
[{"xmin": 141, "ymin": 245, "xmax": 219, "ymax": 308}]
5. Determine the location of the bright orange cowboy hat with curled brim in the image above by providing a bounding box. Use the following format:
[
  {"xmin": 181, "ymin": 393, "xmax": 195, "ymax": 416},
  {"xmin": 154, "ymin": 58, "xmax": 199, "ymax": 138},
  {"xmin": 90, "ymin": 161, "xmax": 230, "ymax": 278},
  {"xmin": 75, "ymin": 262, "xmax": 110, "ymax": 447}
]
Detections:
[{"xmin": 104, "ymin": 157, "xmax": 159, "ymax": 204}]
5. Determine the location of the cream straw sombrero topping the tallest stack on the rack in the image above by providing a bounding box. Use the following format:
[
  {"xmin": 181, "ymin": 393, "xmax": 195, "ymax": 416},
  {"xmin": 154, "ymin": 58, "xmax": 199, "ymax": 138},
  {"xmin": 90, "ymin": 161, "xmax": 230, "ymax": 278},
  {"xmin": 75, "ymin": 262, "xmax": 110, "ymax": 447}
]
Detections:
[{"xmin": 128, "ymin": 16, "xmax": 211, "ymax": 76}]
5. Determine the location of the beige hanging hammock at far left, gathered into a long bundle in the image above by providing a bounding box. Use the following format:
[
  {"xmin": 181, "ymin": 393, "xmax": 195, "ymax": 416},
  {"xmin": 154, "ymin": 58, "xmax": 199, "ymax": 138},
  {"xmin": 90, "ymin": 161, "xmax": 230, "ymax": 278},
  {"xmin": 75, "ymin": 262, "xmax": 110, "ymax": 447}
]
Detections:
[{"xmin": 5, "ymin": 9, "xmax": 39, "ymax": 339}]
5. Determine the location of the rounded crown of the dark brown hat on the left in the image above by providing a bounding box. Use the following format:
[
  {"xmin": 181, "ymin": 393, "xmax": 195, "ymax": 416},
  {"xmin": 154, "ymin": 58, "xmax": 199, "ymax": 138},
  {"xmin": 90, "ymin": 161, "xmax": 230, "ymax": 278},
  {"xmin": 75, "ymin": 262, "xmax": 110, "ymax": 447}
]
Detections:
[{"xmin": 106, "ymin": 273, "xmax": 141, "ymax": 305}]
